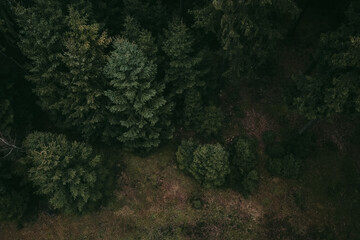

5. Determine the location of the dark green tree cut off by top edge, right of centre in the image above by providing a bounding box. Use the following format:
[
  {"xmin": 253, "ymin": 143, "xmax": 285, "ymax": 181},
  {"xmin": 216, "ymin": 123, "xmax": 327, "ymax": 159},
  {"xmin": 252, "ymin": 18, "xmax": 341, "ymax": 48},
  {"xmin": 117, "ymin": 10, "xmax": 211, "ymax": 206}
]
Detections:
[{"xmin": 192, "ymin": 0, "xmax": 299, "ymax": 79}]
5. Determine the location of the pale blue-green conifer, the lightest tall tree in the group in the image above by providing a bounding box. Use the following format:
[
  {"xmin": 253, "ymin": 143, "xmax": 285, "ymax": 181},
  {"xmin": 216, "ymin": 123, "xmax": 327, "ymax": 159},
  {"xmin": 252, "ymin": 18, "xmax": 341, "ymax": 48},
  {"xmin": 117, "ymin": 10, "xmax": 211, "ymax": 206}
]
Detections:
[{"xmin": 104, "ymin": 39, "xmax": 173, "ymax": 150}]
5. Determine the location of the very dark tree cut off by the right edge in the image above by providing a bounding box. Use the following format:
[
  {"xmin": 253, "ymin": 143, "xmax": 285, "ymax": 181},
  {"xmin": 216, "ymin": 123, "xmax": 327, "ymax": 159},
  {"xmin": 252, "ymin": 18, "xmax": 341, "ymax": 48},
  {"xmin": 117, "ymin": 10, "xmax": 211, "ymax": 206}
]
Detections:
[{"xmin": 294, "ymin": 1, "xmax": 360, "ymax": 119}]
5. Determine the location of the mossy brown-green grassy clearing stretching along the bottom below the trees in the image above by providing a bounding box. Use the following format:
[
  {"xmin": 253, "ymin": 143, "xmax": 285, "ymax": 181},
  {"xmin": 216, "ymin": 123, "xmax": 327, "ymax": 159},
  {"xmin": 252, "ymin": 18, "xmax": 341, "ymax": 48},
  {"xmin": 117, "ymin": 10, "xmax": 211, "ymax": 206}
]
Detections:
[{"xmin": 0, "ymin": 136, "xmax": 354, "ymax": 240}]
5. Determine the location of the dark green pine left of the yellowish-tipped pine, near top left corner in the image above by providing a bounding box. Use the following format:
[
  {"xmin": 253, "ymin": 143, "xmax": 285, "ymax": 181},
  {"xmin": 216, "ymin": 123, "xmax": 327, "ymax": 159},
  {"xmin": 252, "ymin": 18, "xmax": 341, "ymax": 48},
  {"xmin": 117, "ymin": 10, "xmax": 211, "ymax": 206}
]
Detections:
[{"xmin": 16, "ymin": 0, "xmax": 67, "ymax": 118}]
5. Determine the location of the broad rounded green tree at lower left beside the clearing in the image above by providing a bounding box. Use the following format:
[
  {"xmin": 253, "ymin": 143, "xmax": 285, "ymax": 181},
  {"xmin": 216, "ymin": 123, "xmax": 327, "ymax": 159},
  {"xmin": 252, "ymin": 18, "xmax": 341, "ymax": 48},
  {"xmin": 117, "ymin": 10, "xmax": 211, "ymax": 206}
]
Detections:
[{"xmin": 23, "ymin": 132, "xmax": 107, "ymax": 213}]
